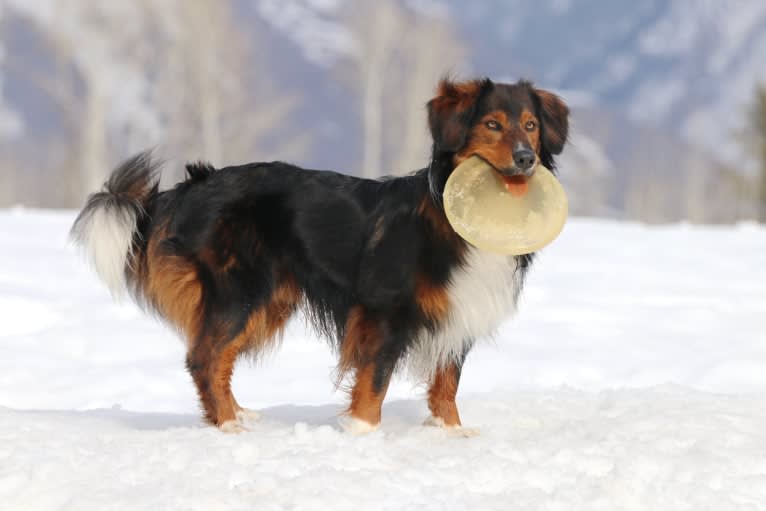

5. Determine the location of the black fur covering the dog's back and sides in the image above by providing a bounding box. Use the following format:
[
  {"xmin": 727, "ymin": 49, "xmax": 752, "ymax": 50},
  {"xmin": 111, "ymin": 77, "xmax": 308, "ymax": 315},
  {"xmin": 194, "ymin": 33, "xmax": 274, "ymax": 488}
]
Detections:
[{"xmin": 140, "ymin": 162, "xmax": 438, "ymax": 346}]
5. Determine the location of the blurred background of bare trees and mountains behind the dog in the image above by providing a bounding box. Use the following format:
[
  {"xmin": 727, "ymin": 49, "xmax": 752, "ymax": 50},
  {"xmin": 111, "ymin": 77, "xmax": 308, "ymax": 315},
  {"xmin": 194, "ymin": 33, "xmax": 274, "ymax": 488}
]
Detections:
[{"xmin": 0, "ymin": 0, "xmax": 766, "ymax": 223}]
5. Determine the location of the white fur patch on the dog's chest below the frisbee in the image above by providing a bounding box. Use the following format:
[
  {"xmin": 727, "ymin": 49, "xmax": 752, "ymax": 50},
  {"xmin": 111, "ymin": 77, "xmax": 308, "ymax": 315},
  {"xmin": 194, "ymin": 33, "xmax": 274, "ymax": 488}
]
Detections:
[{"xmin": 407, "ymin": 248, "xmax": 523, "ymax": 381}]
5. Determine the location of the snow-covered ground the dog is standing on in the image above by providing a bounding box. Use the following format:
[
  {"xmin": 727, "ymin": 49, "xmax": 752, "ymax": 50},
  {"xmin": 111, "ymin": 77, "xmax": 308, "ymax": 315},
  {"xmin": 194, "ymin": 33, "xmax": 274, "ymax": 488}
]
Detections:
[{"xmin": 0, "ymin": 210, "xmax": 766, "ymax": 511}]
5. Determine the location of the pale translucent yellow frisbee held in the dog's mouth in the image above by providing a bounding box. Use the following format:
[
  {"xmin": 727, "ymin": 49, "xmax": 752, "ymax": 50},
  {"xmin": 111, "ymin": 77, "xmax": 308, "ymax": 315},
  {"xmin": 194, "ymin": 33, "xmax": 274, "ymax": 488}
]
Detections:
[{"xmin": 443, "ymin": 156, "xmax": 568, "ymax": 255}]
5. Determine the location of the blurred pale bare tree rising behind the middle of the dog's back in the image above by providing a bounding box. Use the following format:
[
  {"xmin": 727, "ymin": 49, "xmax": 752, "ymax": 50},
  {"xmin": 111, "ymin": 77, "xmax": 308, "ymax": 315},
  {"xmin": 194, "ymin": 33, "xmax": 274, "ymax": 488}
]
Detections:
[{"xmin": 143, "ymin": 0, "xmax": 310, "ymax": 176}]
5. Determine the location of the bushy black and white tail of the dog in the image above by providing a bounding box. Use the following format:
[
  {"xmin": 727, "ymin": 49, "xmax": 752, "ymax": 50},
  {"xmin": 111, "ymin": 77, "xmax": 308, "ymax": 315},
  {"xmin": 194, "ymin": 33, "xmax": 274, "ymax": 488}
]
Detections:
[{"xmin": 69, "ymin": 151, "xmax": 159, "ymax": 297}]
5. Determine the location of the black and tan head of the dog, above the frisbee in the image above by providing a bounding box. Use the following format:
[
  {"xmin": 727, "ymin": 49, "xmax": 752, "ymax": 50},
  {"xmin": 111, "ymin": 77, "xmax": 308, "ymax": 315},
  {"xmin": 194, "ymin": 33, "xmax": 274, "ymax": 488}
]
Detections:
[{"xmin": 428, "ymin": 79, "xmax": 569, "ymax": 180}]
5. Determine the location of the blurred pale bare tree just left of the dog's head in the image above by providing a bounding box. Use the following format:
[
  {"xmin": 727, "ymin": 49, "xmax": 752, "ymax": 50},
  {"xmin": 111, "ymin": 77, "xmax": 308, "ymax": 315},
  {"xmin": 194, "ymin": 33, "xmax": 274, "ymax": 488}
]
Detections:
[{"xmin": 340, "ymin": 0, "xmax": 466, "ymax": 177}]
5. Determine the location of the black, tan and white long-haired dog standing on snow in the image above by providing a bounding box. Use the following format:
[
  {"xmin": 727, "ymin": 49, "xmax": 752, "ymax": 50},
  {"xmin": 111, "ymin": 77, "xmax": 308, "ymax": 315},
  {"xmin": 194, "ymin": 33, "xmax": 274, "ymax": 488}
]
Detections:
[{"xmin": 71, "ymin": 78, "xmax": 569, "ymax": 433}]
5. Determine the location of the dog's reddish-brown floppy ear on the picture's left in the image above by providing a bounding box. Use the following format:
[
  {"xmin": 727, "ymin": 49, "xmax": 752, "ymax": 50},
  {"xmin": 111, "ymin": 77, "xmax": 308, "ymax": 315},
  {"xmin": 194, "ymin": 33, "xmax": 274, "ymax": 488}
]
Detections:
[{"xmin": 428, "ymin": 78, "xmax": 494, "ymax": 152}]
